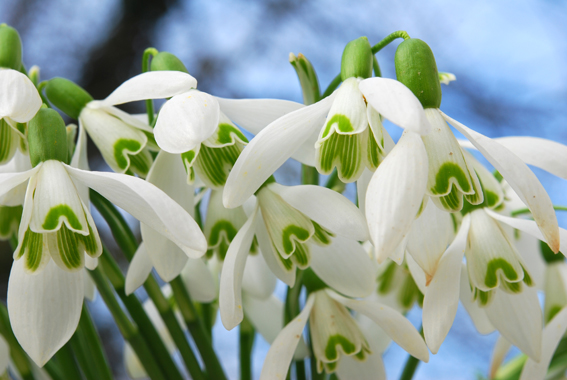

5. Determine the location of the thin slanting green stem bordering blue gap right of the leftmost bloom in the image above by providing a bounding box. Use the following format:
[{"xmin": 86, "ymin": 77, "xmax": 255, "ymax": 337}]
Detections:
[{"xmin": 89, "ymin": 267, "xmax": 167, "ymax": 380}]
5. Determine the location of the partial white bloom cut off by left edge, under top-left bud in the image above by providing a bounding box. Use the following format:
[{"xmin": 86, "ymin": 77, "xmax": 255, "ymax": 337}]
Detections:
[{"xmin": 0, "ymin": 68, "xmax": 42, "ymax": 165}]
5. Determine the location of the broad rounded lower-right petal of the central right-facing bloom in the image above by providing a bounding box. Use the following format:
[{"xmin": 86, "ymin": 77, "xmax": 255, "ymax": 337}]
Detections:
[{"xmin": 310, "ymin": 237, "xmax": 376, "ymax": 297}]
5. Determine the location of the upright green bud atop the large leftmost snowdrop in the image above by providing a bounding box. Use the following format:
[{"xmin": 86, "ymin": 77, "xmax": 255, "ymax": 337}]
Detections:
[{"xmin": 28, "ymin": 108, "xmax": 69, "ymax": 167}]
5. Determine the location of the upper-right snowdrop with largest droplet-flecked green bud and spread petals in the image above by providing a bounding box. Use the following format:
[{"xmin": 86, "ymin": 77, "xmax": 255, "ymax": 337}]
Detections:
[{"xmin": 359, "ymin": 39, "xmax": 559, "ymax": 260}]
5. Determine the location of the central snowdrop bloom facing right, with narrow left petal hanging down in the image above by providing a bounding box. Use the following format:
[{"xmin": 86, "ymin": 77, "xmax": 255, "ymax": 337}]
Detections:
[{"xmin": 219, "ymin": 182, "xmax": 374, "ymax": 330}]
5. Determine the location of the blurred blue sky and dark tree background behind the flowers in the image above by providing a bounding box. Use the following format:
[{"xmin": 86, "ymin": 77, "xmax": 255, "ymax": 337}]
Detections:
[{"xmin": 0, "ymin": 0, "xmax": 567, "ymax": 379}]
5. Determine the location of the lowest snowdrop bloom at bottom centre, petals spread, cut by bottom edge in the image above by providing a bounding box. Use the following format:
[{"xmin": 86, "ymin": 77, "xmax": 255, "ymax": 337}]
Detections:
[{"xmin": 260, "ymin": 289, "xmax": 429, "ymax": 380}]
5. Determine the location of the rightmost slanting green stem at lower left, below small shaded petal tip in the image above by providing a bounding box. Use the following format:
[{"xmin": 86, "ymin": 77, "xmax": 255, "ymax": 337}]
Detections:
[{"xmin": 170, "ymin": 276, "xmax": 226, "ymax": 380}]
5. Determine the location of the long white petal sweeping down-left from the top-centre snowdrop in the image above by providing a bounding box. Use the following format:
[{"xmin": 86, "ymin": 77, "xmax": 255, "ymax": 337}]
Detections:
[{"xmin": 223, "ymin": 95, "xmax": 334, "ymax": 208}]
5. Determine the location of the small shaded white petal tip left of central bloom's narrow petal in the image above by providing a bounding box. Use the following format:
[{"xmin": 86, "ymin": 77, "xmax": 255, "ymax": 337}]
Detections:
[{"xmin": 181, "ymin": 259, "xmax": 218, "ymax": 303}]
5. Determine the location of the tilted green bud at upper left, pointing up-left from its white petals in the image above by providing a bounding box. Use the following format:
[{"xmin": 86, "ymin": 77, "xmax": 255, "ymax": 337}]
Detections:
[{"xmin": 45, "ymin": 78, "xmax": 93, "ymax": 119}]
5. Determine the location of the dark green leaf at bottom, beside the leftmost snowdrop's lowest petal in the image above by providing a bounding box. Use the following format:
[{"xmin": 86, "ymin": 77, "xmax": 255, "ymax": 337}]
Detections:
[{"xmin": 71, "ymin": 303, "xmax": 113, "ymax": 380}]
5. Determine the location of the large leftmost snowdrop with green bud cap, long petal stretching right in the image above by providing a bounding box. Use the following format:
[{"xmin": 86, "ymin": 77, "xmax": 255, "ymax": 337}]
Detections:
[{"xmin": 0, "ymin": 109, "xmax": 206, "ymax": 366}]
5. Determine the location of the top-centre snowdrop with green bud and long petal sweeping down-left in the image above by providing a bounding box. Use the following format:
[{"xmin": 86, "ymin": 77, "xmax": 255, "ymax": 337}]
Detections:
[{"xmin": 223, "ymin": 37, "xmax": 394, "ymax": 208}]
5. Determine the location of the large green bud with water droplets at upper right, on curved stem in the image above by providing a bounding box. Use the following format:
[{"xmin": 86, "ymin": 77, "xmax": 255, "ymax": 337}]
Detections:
[{"xmin": 395, "ymin": 38, "xmax": 441, "ymax": 108}]
